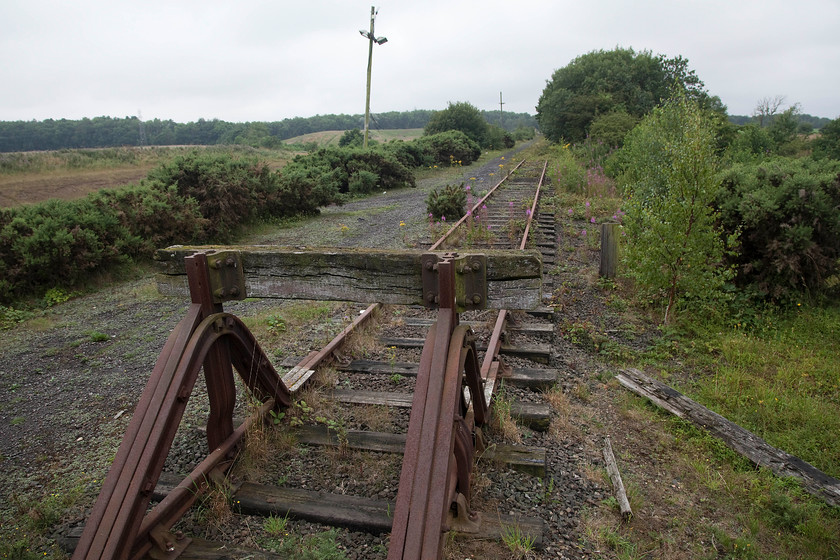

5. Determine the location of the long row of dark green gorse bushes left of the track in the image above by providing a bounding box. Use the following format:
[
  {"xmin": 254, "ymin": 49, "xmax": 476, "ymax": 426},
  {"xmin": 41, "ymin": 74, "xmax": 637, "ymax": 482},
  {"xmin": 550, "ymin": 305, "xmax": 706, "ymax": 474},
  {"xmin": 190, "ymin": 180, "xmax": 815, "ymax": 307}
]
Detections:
[{"xmin": 0, "ymin": 131, "xmax": 492, "ymax": 303}]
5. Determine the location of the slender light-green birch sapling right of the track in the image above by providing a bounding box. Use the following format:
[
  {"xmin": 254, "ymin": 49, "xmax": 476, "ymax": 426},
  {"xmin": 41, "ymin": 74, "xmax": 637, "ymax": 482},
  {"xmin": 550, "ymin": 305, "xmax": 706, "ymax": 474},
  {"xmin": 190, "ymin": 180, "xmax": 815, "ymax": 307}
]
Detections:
[{"xmin": 623, "ymin": 90, "xmax": 731, "ymax": 323}]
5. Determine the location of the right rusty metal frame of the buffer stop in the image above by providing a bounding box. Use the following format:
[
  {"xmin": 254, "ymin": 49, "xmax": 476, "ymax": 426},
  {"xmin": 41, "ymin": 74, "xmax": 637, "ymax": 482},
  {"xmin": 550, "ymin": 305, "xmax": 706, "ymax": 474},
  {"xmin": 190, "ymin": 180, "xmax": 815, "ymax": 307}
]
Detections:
[{"xmin": 388, "ymin": 258, "xmax": 488, "ymax": 560}]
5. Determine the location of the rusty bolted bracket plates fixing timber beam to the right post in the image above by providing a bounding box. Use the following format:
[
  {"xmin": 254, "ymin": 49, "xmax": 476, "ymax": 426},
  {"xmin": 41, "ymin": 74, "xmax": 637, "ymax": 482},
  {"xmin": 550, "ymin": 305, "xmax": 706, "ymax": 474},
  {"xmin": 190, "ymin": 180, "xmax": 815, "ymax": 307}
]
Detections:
[{"xmin": 420, "ymin": 253, "xmax": 487, "ymax": 313}]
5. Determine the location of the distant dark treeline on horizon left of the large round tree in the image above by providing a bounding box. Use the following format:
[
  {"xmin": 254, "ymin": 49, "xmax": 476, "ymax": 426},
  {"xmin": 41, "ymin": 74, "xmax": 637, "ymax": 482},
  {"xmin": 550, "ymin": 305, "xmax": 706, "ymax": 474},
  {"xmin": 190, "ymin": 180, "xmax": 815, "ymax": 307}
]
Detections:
[{"xmin": 0, "ymin": 109, "xmax": 537, "ymax": 152}]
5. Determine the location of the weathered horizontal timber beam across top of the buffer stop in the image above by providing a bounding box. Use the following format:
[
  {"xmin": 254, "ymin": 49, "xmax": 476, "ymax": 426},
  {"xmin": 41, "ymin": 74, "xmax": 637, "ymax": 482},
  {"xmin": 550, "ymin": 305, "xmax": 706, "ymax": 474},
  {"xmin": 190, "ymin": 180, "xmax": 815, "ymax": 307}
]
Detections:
[{"xmin": 155, "ymin": 245, "xmax": 542, "ymax": 309}]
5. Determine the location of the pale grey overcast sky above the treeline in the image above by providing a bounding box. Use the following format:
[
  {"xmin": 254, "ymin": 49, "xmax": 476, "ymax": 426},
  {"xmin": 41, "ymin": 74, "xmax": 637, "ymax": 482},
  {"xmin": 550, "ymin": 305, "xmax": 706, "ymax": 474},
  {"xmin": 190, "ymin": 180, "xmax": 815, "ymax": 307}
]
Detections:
[{"xmin": 0, "ymin": 0, "xmax": 840, "ymax": 122}]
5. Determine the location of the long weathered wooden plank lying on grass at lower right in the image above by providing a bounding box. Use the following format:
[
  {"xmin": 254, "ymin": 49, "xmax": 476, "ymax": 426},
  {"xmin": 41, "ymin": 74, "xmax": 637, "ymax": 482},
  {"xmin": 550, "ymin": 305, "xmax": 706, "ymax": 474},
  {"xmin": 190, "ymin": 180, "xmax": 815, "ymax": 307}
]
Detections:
[{"xmin": 616, "ymin": 368, "xmax": 840, "ymax": 506}]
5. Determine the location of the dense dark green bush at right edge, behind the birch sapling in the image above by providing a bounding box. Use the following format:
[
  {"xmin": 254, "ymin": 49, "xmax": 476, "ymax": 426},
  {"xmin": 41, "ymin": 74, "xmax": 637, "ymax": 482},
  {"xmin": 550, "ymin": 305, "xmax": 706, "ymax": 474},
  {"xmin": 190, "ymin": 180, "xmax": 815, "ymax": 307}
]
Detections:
[{"xmin": 717, "ymin": 157, "xmax": 840, "ymax": 301}]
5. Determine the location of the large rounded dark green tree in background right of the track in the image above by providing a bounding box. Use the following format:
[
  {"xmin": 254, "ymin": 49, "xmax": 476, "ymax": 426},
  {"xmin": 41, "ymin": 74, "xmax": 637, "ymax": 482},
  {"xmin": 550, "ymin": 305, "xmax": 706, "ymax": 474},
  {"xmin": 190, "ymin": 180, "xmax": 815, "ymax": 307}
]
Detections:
[{"xmin": 537, "ymin": 48, "xmax": 709, "ymax": 142}]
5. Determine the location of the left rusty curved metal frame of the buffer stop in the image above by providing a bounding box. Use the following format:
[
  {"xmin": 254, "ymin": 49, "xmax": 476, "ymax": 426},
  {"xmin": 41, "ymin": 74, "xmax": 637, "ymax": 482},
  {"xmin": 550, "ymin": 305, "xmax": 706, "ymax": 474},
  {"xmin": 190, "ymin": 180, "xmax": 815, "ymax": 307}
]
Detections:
[{"xmin": 73, "ymin": 253, "xmax": 291, "ymax": 560}]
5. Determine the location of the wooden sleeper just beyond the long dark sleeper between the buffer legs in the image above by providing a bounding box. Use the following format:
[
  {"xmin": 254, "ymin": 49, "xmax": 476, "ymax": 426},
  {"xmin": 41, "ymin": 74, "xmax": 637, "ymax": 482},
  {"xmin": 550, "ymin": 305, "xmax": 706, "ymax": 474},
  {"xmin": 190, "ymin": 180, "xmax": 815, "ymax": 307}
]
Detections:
[{"xmin": 295, "ymin": 426, "xmax": 546, "ymax": 477}]
